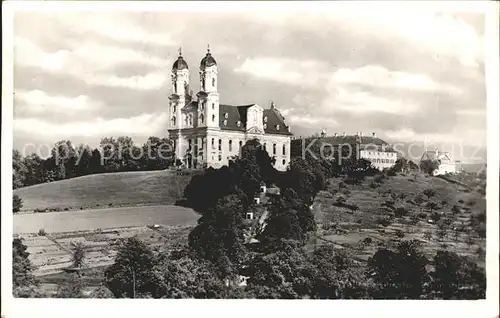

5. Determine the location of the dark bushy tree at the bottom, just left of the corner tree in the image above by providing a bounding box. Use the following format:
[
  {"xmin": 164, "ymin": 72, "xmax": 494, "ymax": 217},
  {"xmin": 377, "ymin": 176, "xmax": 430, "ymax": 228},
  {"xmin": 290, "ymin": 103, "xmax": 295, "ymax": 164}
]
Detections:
[{"xmin": 368, "ymin": 241, "xmax": 428, "ymax": 299}]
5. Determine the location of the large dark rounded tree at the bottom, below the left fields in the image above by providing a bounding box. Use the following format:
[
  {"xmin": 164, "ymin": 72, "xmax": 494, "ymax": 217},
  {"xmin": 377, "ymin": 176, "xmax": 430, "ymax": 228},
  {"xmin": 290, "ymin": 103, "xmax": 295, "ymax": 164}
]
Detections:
[{"xmin": 104, "ymin": 237, "xmax": 154, "ymax": 298}]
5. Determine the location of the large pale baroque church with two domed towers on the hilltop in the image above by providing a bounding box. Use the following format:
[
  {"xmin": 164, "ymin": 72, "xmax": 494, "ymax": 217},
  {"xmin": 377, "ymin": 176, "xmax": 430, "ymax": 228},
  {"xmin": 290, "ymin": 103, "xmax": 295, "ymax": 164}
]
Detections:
[{"xmin": 168, "ymin": 49, "xmax": 292, "ymax": 171}]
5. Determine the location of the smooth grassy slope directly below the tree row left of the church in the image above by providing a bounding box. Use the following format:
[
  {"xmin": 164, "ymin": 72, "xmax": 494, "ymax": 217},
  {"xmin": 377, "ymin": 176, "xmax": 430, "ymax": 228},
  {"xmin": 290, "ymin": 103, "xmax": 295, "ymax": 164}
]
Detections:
[{"xmin": 14, "ymin": 171, "xmax": 191, "ymax": 211}]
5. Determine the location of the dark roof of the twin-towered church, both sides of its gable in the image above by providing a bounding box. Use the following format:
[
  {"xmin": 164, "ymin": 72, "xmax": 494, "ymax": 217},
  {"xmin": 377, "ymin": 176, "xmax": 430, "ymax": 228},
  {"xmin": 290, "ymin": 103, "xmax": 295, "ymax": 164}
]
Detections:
[{"xmin": 219, "ymin": 104, "xmax": 292, "ymax": 135}]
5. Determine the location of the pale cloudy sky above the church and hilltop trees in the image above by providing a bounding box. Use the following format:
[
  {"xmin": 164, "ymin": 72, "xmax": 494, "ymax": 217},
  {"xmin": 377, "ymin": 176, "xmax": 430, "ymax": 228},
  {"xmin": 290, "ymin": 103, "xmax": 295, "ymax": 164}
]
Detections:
[{"xmin": 14, "ymin": 6, "xmax": 486, "ymax": 160}]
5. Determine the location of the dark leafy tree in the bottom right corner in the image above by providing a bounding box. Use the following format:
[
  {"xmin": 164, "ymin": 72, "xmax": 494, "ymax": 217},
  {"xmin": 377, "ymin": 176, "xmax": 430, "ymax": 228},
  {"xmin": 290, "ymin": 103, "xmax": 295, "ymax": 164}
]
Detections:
[{"xmin": 431, "ymin": 251, "xmax": 486, "ymax": 300}]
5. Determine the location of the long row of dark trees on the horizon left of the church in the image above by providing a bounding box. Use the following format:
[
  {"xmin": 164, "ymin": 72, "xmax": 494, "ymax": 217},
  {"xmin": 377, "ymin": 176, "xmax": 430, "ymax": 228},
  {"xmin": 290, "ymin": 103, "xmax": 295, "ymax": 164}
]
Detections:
[{"xmin": 12, "ymin": 136, "xmax": 174, "ymax": 189}]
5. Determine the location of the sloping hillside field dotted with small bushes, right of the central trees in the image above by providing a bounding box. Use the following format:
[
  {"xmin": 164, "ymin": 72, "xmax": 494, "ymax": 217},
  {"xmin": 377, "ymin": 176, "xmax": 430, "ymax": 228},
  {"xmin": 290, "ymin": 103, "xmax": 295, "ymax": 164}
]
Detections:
[{"xmin": 310, "ymin": 175, "xmax": 486, "ymax": 266}]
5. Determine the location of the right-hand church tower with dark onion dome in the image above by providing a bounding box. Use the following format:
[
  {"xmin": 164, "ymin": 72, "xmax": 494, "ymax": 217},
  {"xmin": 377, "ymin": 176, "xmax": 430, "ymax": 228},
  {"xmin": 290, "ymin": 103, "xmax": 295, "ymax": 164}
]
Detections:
[{"xmin": 197, "ymin": 47, "xmax": 219, "ymax": 128}]
